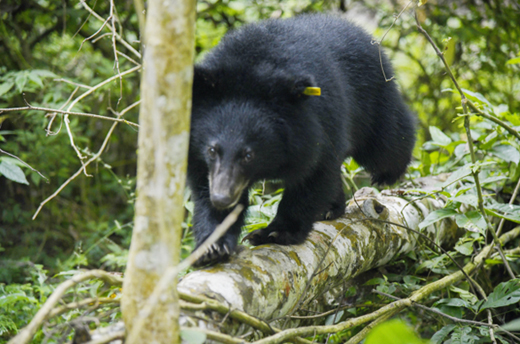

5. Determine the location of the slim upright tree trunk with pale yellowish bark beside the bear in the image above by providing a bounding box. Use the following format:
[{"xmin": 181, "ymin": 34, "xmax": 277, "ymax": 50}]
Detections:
[{"xmin": 121, "ymin": 0, "xmax": 196, "ymax": 344}]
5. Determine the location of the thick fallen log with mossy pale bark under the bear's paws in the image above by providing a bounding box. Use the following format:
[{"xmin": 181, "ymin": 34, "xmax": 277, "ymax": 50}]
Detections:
[{"xmin": 178, "ymin": 188, "xmax": 459, "ymax": 335}]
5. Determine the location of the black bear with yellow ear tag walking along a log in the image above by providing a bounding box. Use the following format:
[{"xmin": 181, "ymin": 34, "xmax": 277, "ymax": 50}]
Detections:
[{"xmin": 188, "ymin": 14, "xmax": 415, "ymax": 265}]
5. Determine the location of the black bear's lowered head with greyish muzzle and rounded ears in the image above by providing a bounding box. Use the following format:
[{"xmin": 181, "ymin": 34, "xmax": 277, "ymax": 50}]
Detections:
[{"xmin": 190, "ymin": 66, "xmax": 314, "ymax": 209}]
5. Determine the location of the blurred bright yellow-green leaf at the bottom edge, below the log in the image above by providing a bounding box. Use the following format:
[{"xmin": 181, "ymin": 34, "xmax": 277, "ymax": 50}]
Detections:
[{"xmin": 365, "ymin": 319, "xmax": 426, "ymax": 344}]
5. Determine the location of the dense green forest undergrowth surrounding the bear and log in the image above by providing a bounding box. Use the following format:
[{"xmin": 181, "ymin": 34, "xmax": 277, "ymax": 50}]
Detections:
[{"xmin": 0, "ymin": 0, "xmax": 520, "ymax": 344}]
